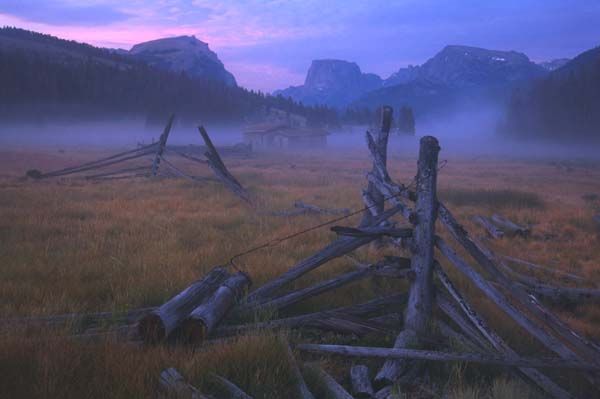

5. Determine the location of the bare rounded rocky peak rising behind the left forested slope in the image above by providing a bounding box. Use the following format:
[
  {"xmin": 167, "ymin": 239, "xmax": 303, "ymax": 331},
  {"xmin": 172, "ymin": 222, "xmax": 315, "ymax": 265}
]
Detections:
[{"xmin": 129, "ymin": 36, "xmax": 236, "ymax": 86}]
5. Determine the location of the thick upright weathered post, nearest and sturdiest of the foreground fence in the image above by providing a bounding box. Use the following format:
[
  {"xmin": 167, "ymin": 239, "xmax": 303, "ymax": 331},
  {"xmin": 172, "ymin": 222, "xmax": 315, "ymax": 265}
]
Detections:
[{"xmin": 375, "ymin": 136, "xmax": 440, "ymax": 385}]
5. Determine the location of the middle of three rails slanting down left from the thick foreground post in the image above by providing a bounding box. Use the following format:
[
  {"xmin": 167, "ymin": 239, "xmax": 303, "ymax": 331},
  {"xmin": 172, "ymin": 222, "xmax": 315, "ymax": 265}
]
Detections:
[{"xmin": 244, "ymin": 263, "xmax": 394, "ymax": 312}]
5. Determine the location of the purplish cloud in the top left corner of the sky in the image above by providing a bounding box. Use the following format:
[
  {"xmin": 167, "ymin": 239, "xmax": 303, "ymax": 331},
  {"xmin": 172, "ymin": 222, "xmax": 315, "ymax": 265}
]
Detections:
[{"xmin": 0, "ymin": 0, "xmax": 130, "ymax": 26}]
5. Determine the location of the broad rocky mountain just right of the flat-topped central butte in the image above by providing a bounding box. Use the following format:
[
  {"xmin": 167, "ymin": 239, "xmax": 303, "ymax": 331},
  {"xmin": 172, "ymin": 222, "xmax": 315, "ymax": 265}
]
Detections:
[{"xmin": 351, "ymin": 45, "xmax": 547, "ymax": 128}]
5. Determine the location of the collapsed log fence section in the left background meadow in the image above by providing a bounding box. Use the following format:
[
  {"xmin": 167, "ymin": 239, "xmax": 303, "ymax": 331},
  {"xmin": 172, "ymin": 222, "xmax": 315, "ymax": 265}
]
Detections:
[{"xmin": 26, "ymin": 115, "xmax": 251, "ymax": 203}]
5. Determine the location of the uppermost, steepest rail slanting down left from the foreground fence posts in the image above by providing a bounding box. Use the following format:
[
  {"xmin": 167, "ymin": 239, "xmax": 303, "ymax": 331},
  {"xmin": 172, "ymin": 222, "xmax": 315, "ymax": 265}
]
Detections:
[{"xmin": 247, "ymin": 207, "xmax": 400, "ymax": 303}]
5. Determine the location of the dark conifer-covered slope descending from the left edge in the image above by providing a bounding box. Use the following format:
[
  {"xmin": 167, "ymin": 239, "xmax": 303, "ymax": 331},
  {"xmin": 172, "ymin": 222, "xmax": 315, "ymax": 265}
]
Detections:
[{"xmin": 0, "ymin": 28, "xmax": 337, "ymax": 124}]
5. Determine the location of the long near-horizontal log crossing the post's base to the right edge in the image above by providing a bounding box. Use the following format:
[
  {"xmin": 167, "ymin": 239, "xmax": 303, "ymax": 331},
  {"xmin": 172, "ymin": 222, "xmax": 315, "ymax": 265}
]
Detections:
[{"xmin": 296, "ymin": 344, "xmax": 600, "ymax": 371}]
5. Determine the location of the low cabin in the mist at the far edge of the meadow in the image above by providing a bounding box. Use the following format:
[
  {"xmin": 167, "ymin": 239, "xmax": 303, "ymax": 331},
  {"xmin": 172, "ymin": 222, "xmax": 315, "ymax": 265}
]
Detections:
[{"xmin": 244, "ymin": 108, "xmax": 329, "ymax": 150}]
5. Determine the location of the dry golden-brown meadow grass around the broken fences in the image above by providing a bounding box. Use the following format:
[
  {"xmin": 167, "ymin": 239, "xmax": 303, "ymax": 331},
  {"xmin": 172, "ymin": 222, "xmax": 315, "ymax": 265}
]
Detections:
[{"xmin": 0, "ymin": 145, "xmax": 600, "ymax": 398}]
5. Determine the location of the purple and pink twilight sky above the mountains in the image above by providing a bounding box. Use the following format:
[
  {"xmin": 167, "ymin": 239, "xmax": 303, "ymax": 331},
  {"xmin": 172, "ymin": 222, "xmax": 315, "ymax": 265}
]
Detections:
[{"xmin": 0, "ymin": 0, "xmax": 600, "ymax": 92}]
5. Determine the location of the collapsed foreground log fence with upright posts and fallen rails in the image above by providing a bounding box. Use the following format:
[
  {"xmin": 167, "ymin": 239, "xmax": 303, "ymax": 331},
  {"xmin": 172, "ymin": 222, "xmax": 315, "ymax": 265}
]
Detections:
[{"xmin": 9, "ymin": 107, "xmax": 600, "ymax": 398}]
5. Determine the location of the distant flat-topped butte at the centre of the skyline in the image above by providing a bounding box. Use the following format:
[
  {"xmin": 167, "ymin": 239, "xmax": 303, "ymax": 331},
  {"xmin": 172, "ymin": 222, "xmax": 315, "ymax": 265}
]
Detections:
[{"xmin": 274, "ymin": 60, "xmax": 382, "ymax": 107}]
